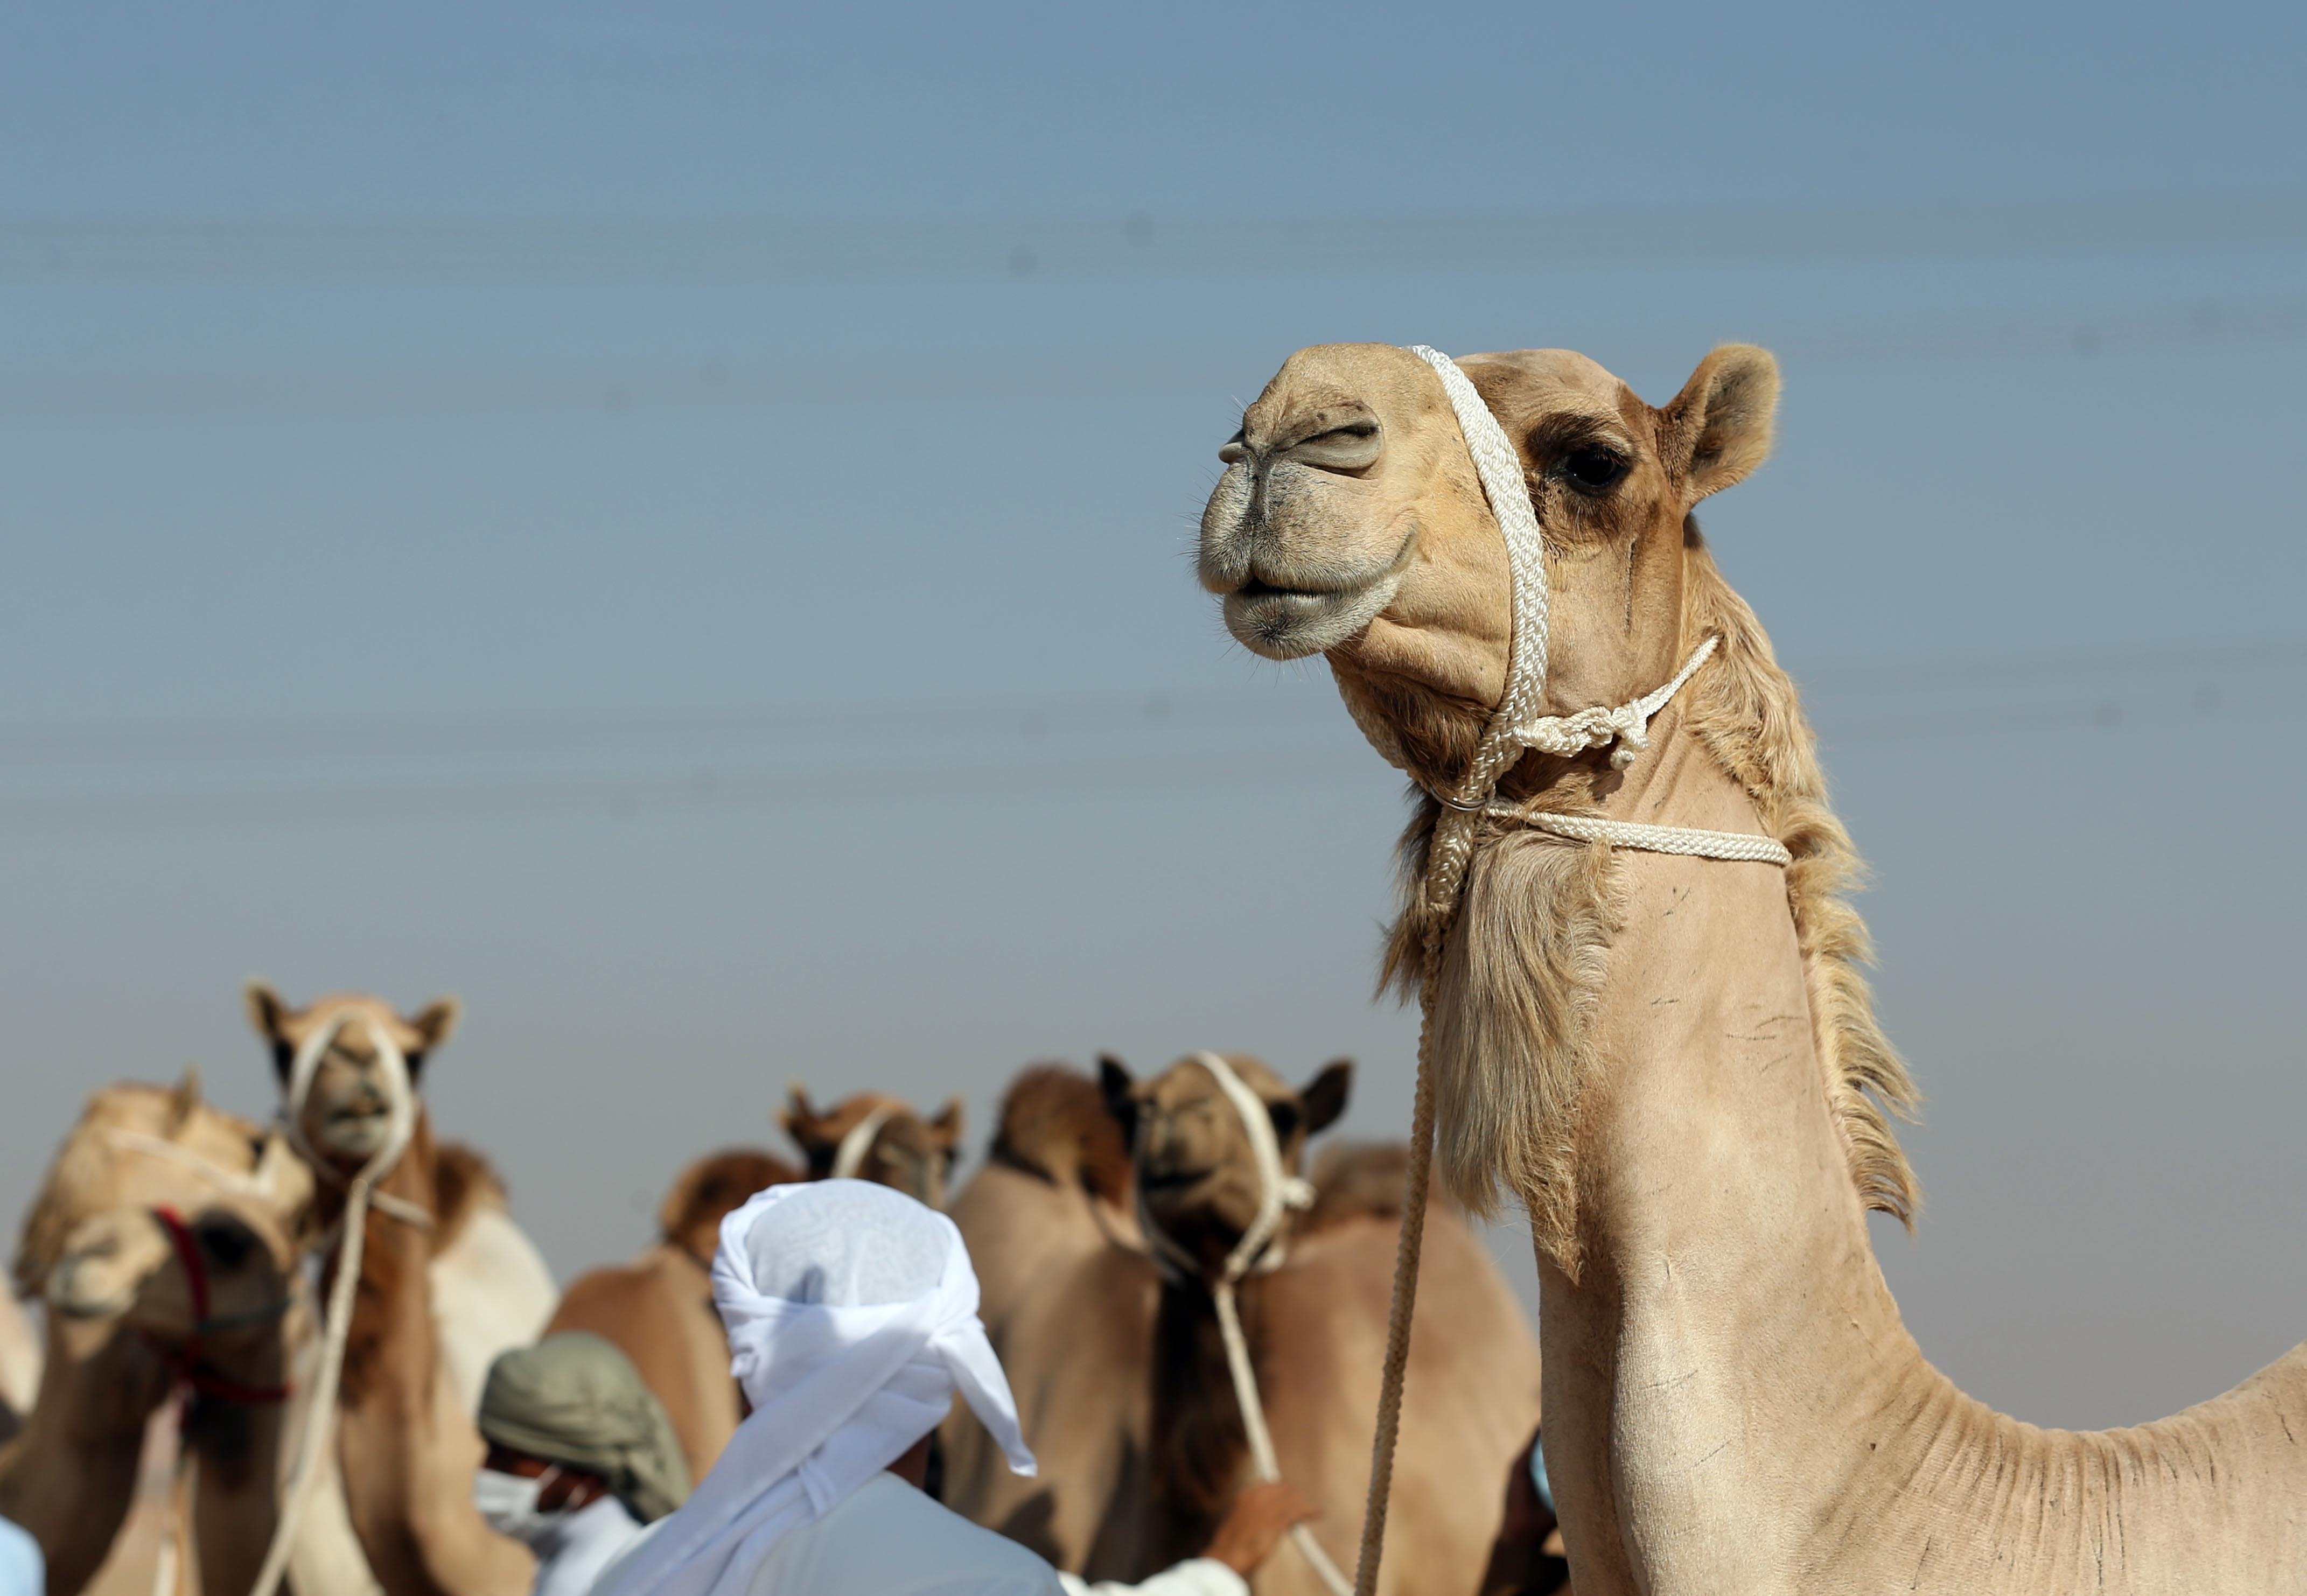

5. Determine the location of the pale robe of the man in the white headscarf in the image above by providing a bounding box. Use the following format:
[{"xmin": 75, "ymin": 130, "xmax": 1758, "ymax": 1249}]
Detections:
[{"xmin": 595, "ymin": 1474, "xmax": 1250, "ymax": 1596}]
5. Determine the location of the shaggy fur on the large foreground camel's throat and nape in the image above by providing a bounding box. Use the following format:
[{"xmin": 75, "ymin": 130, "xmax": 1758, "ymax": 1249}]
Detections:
[{"xmin": 1366, "ymin": 533, "xmax": 1915, "ymax": 1280}]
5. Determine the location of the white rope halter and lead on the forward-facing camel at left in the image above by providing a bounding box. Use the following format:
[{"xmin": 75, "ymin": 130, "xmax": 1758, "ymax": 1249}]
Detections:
[{"xmin": 249, "ymin": 1015, "xmax": 431, "ymax": 1596}]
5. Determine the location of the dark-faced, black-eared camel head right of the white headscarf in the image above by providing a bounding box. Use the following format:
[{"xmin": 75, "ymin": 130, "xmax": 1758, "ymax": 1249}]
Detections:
[{"xmin": 1098, "ymin": 1054, "xmax": 1354, "ymax": 1273}]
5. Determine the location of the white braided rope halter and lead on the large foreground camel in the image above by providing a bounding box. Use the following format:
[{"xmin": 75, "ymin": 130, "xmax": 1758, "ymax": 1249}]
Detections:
[{"xmin": 1354, "ymin": 344, "xmax": 1793, "ymax": 1596}]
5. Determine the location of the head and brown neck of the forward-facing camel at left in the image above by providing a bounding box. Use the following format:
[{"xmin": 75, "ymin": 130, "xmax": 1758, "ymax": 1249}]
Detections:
[{"xmin": 249, "ymin": 985, "xmax": 544, "ymax": 1596}]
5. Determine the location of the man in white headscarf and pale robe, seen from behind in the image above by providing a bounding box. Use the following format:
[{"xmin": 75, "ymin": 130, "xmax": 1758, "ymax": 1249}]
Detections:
[{"xmin": 593, "ymin": 1181, "xmax": 1308, "ymax": 1596}]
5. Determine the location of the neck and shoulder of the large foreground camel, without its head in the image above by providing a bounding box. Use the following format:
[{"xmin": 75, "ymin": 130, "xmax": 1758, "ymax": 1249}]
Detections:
[{"xmin": 1347, "ymin": 549, "xmax": 2307, "ymax": 1596}]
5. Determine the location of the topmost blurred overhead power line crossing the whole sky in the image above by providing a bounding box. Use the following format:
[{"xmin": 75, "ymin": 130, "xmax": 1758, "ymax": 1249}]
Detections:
[{"xmin": 0, "ymin": 196, "xmax": 2307, "ymax": 284}]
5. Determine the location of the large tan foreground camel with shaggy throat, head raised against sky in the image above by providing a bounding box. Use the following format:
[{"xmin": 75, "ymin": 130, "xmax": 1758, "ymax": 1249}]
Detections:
[{"xmin": 1202, "ymin": 346, "xmax": 2307, "ymax": 1596}]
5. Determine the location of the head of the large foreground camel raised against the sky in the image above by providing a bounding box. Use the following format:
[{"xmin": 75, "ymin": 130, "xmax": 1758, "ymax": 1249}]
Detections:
[{"xmin": 1200, "ymin": 344, "xmax": 1779, "ymax": 787}]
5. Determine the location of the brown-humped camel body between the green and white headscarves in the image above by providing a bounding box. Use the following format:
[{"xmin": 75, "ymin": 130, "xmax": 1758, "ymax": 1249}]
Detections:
[{"xmin": 544, "ymin": 1149, "xmax": 803, "ymax": 1481}]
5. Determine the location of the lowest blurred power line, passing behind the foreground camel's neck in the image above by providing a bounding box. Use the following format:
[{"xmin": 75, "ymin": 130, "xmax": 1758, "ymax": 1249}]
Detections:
[{"xmin": 0, "ymin": 641, "xmax": 2307, "ymax": 835}]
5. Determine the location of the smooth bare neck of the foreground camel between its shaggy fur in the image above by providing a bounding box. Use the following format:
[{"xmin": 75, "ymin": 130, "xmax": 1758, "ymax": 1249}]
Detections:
[{"xmin": 1541, "ymin": 715, "xmax": 1924, "ymax": 1591}]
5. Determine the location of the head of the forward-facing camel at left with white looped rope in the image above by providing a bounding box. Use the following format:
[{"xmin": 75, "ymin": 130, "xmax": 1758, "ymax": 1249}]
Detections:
[{"xmin": 247, "ymin": 980, "xmax": 462, "ymax": 1176}]
